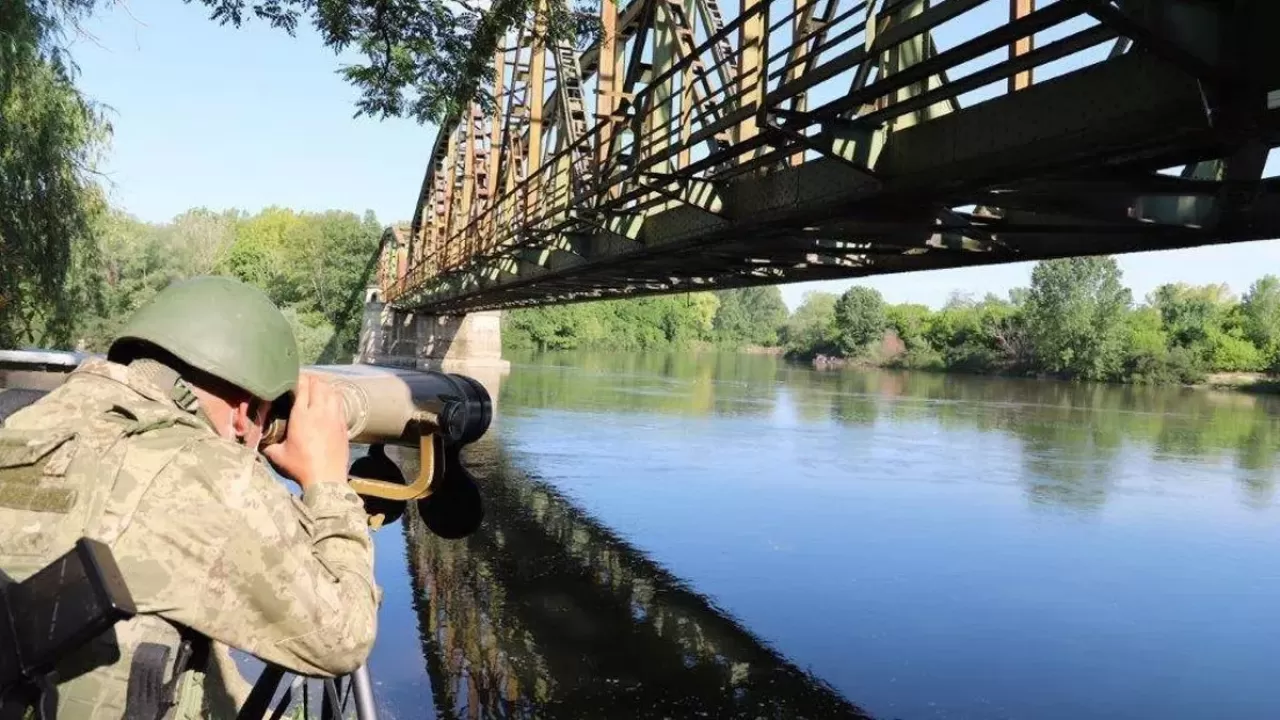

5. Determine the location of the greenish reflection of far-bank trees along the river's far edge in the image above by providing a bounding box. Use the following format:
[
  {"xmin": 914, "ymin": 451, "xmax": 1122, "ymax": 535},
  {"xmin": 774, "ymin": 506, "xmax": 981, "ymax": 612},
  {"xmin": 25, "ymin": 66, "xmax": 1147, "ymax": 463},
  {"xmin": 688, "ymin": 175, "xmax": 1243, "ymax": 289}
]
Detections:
[{"xmin": 502, "ymin": 352, "xmax": 1280, "ymax": 511}]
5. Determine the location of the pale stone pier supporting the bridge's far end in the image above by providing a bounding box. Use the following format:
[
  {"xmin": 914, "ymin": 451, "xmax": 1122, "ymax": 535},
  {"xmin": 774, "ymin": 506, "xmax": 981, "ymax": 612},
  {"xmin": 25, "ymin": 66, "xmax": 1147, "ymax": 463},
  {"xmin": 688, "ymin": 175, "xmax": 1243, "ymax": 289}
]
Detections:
[{"xmin": 353, "ymin": 288, "xmax": 511, "ymax": 409}]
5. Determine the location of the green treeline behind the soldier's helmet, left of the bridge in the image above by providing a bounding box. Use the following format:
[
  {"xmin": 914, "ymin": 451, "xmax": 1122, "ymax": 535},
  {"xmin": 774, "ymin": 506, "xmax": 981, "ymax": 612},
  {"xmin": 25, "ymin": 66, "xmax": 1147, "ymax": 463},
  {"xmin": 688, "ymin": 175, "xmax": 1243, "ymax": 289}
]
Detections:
[{"xmin": 0, "ymin": 208, "xmax": 383, "ymax": 363}]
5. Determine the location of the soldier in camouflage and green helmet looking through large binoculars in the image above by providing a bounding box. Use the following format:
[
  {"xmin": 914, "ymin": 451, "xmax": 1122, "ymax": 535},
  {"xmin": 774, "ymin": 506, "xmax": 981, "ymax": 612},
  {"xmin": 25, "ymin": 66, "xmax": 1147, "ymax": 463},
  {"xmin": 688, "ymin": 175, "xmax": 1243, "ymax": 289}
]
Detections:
[{"xmin": 0, "ymin": 278, "xmax": 381, "ymax": 720}]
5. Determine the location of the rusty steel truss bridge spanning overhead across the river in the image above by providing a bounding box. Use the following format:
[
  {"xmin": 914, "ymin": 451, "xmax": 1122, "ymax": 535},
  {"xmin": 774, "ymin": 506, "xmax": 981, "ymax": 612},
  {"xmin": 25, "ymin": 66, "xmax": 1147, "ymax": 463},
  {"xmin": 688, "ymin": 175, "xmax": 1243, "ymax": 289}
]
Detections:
[{"xmin": 380, "ymin": 0, "xmax": 1280, "ymax": 313}]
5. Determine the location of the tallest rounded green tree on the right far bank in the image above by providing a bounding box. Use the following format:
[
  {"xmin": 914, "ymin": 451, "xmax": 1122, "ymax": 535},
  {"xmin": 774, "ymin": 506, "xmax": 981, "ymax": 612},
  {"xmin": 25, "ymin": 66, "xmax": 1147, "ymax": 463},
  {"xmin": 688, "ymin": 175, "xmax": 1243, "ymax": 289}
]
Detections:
[{"xmin": 1025, "ymin": 256, "xmax": 1133, "ymax": 380}]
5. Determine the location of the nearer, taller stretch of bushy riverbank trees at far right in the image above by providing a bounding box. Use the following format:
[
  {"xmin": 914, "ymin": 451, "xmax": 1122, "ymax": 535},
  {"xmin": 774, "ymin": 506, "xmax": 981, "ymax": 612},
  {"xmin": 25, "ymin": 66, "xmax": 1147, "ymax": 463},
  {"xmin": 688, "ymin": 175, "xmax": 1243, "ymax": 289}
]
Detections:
[{"xmin": 782, "ymin": 258, "xmax": 1280, "ymax": 383}]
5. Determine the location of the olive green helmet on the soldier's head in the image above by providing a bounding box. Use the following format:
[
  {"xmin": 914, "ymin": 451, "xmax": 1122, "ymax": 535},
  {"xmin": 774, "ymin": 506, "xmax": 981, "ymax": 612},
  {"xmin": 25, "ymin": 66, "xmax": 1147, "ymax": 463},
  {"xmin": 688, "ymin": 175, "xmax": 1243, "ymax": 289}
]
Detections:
[{"xmin": 109, "ymin": 277, "xmax": 301, "ymax": 401}]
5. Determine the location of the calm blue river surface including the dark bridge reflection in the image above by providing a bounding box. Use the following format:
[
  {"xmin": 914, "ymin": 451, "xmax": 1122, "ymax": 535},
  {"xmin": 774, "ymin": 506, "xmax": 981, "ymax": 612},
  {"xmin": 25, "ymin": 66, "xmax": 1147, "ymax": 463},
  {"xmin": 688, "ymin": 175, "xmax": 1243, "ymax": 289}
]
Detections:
[{"xmin": 358, "ymin": 354, "xmax": 1280, "ymax": 720}]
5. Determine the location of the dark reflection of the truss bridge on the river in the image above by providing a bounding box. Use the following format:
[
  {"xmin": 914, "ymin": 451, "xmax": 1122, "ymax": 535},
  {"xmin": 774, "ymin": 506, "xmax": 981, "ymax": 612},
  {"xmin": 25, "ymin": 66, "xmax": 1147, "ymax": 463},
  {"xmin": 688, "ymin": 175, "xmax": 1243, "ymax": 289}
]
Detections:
[{"xmin": 402, "ymin": 438, "xmax": 870, "ymax": 720}]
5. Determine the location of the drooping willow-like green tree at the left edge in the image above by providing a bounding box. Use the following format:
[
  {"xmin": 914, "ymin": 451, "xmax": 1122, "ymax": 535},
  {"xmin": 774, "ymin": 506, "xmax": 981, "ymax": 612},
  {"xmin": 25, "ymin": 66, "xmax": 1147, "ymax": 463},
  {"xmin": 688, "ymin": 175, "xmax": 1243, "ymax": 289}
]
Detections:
[{"xmin": 0, "ymin": 0, "xmax": 110, "ymax": 347}]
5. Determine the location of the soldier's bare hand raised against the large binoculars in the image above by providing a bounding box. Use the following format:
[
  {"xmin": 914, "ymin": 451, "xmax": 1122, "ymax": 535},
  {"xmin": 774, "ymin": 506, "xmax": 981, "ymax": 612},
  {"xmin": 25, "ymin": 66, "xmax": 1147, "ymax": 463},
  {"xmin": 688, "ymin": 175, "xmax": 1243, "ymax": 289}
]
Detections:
[{"xmin": 262, "ymin": 373, "xmax": 351, "ymax": 491}]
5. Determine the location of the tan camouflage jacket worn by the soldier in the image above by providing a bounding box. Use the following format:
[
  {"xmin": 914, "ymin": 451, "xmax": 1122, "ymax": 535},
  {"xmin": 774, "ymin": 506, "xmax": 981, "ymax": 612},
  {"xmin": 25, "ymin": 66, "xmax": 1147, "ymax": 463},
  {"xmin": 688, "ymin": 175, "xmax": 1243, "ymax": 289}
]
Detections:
[{"xmin": 0, "ymin": 359, "xmax": 381, "ymax": 717}]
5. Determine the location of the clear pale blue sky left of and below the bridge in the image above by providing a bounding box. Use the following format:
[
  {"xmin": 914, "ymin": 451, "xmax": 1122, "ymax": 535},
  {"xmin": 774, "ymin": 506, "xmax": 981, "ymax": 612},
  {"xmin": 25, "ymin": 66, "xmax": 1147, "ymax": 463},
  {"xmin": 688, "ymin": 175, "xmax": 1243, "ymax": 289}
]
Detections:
[{"xmin": 67, "ymin": 0, "xmax": 1280, "ymax": 307}]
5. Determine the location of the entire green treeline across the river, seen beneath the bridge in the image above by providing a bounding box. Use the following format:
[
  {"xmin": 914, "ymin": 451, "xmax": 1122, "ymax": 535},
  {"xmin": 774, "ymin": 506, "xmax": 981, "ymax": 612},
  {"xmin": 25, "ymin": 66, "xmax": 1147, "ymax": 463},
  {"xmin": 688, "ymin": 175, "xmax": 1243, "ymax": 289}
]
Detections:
[{"xmin": 504, "ymin": 256, "xmax": 1280, "ymax": 383}]
